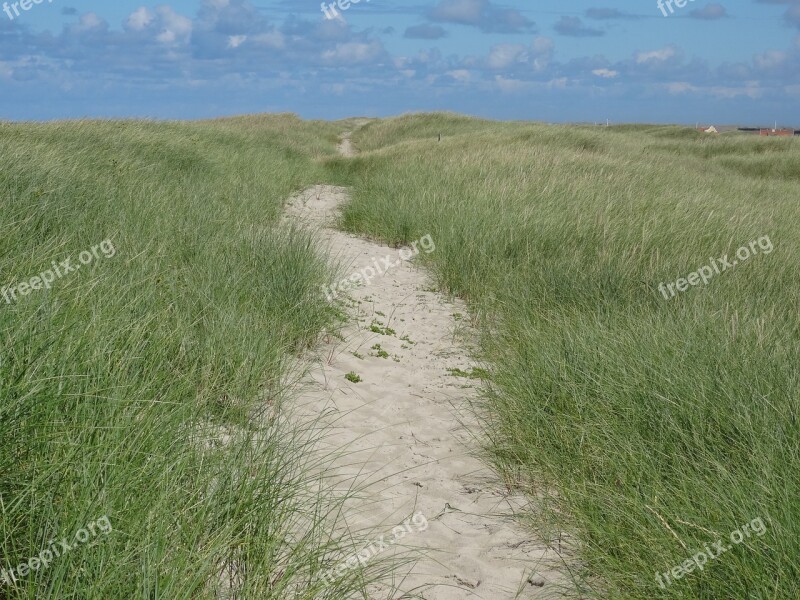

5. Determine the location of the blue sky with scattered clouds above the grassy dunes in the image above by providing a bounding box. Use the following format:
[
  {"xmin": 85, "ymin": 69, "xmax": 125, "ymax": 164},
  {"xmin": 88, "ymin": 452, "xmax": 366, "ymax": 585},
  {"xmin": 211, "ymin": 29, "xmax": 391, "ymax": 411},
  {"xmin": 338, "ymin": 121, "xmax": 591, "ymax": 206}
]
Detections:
[{"xmin": 0, "ymin": 0, "xmax": 800, "ymax": 128}]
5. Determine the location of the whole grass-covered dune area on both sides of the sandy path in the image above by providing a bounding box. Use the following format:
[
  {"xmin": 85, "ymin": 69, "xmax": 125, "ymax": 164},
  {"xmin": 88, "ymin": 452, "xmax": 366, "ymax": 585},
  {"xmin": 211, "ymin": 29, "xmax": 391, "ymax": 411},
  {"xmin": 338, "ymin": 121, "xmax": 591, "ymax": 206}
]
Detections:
[{"xmin": 0, "ymin": 114, "xmax": 800, "ymax": 600}]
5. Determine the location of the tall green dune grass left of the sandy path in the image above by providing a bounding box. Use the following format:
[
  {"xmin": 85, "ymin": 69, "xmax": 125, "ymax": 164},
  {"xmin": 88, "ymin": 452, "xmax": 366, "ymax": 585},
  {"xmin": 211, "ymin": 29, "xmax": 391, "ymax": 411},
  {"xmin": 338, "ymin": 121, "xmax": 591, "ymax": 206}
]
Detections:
[{"xmin": 0, "ymin": 115, "xmax": 390, "ymax": 600}]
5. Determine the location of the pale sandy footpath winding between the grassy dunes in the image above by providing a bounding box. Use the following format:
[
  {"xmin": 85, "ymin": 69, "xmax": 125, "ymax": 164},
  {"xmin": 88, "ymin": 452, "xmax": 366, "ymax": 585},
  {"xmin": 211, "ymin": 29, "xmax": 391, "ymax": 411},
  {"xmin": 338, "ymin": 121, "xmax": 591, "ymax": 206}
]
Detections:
[{"xmin": 285, "ymin": 134, "xmax": 563, "ymax": 600}]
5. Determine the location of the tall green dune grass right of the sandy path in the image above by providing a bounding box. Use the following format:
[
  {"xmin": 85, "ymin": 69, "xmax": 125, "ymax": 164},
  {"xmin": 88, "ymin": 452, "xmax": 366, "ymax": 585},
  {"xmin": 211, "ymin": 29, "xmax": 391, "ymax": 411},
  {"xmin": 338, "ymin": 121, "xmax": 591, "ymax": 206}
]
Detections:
[{"xmin": 338, "ymin": 114, "xmax": 800, "ymax": 600}]
